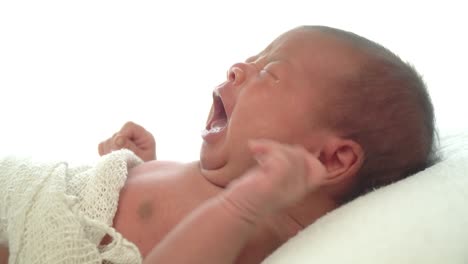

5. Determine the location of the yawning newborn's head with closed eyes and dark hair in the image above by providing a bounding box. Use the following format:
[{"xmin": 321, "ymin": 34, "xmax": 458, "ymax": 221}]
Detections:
[{"xmin": 200, "ymin": 26, "xmax": 434, "ymax": 203}]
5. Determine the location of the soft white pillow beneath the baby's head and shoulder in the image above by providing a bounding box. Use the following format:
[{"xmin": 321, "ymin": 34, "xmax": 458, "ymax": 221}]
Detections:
[{"xmin": 264, "ymin": 148, "xmax": 468, "ymax": 264}]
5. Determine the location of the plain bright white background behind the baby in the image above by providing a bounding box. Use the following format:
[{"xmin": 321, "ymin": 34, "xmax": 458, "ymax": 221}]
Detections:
[{"xmin": 0, "ymin": 0, "xmax": 468, "ymax": 161}]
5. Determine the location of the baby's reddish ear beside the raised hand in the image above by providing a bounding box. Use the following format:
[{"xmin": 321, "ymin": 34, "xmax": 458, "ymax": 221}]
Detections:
[{"xmin": 319, "ymin": 137, "xmax": 364, "ymax": 185}]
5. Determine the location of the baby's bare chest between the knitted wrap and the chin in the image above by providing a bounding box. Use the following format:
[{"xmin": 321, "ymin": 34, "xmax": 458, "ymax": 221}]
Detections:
[{"xmin": 113, "ymin": 161, "xmax": 221, "ymax": 256}]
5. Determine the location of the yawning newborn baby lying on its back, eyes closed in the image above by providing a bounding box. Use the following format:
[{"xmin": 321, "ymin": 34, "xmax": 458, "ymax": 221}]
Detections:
[{"xmin": 0, "ymin": 26, "xmax": 434, "ymax": 263}]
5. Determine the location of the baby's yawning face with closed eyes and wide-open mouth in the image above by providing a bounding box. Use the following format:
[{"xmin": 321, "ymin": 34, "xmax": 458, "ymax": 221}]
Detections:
[{"xmin": 200, "ymin": 27, "xmax": 356, "ymax": 186}]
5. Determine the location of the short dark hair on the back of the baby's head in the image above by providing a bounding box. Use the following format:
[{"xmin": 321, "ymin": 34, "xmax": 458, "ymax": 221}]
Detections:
[{"xmin": 308, "ymin": 26, "xmax": 438, "ymax": 203}]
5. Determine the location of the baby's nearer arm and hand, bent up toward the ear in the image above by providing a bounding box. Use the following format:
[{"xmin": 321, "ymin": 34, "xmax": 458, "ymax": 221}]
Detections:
[{"xmin": 145, "ymin": 140, "xmax": 325, "ymax": 264}]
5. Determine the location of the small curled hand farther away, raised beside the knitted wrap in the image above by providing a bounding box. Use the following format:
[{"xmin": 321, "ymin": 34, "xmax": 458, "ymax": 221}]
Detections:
[{"xmin": 99, "ymin": 122, "xmax": 156, "ymax": 161}]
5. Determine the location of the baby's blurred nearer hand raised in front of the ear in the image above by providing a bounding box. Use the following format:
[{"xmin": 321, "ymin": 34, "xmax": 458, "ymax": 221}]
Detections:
[{"xmin": 224, "ymin": 140, "xmax": 327, "ymax": 222}]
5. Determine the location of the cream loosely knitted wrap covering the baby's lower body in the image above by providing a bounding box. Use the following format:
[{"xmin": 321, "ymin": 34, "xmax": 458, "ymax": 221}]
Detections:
[{"xmin": 0, "ymin": 150, "xmax": 141, "ymax": 264}]
